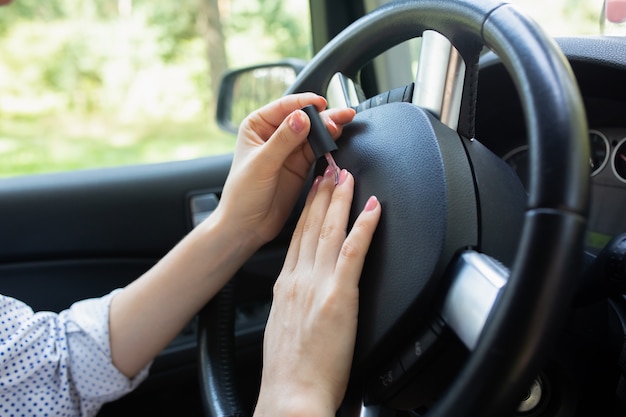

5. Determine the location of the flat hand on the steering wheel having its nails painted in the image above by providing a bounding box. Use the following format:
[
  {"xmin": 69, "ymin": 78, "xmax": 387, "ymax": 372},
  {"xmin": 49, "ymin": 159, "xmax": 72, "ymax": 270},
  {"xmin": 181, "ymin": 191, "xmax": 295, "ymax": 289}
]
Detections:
[{"xmin": 255, "ymin": 170, "xmax": 381, "ymax": 417}]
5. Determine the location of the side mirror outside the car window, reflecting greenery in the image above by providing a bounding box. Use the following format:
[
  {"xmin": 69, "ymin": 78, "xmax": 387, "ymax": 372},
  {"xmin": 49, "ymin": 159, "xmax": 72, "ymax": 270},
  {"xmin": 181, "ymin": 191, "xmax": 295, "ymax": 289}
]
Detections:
[{"xmin": 217, "ymin": 60, "xmax": 306, "ymax": 133}]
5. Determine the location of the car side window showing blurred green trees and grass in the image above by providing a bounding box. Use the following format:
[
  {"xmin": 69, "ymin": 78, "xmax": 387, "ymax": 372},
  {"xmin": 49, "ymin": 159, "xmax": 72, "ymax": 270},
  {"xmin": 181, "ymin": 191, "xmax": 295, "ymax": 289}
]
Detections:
[{"xmin": 0, "ymin": 0, "xmax": 311, "ymax": 178}]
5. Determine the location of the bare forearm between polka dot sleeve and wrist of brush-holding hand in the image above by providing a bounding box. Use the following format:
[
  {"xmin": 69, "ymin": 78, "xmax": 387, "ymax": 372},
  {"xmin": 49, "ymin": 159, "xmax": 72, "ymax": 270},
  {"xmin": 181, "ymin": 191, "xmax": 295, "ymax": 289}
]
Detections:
[{"xmin": 109, "ymin": 208, "xmax": 258, "ymax": 377}]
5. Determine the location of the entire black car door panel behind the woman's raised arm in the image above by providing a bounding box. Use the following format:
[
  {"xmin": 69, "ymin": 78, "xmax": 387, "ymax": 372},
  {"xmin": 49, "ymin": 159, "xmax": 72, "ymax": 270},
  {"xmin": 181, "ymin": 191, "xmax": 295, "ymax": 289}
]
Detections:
[{"xmin": 0, "ymin": 155, "xmax": 236, "ymax": 415}]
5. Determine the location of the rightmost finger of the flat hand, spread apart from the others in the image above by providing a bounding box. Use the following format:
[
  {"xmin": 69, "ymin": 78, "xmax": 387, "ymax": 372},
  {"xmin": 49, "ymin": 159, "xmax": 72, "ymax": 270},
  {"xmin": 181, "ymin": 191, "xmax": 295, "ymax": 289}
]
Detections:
[{"xmin": 336, "ymin": 196, "xmax": 381, "ymax": 288}]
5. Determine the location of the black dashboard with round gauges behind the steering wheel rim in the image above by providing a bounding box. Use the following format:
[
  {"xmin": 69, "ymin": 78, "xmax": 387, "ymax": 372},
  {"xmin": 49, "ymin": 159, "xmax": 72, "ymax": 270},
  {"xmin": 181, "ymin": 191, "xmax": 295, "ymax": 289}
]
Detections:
[{"xmin": 476, "ymin": 37, "xmax": 626, "ymax": 255}]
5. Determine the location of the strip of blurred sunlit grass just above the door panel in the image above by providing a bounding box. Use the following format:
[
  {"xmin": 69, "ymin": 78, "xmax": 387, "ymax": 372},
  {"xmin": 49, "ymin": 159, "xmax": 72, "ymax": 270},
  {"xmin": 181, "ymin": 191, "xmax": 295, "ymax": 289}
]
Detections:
[{"xmin": 0, "ymin": 115, "xmax": 235, "ymax": 177}]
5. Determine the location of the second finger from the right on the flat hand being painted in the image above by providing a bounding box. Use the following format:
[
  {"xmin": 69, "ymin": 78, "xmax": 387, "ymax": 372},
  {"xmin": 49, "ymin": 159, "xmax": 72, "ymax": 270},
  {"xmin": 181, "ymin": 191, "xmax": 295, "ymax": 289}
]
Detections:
[{"xmin": 316, "ymin": 169, "xmax": 354, "ymax": 266}]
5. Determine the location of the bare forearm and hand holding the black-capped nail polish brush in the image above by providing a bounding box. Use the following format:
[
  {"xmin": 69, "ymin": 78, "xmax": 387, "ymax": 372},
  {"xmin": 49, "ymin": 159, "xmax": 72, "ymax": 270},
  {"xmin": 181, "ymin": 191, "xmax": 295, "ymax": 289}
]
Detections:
[{"xmin": 109, "ymin": 93, "xmax": 354, "ymax": 377}]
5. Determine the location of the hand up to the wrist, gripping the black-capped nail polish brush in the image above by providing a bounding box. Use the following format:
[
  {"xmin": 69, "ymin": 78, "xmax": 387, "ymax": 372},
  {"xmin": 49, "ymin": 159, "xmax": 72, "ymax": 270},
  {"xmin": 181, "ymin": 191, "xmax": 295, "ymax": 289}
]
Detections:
[{"xmin": 212, "ymin": 93, "xmax": 355, "ymax": 247}]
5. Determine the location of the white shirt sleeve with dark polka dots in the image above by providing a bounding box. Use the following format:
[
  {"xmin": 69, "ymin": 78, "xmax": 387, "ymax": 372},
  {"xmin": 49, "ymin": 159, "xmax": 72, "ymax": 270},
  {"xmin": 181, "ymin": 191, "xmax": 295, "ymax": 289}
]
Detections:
[{"xmin": 0, "ymin": 290, "xmax": 148, "ymax": 416}]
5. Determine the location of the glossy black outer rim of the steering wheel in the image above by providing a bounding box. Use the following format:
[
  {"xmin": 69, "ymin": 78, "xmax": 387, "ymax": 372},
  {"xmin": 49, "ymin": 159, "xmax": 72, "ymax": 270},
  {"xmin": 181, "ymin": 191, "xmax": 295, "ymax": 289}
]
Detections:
[{"xmin": 200, "ymin": 0, "xmax": 589, "ymax": 416}]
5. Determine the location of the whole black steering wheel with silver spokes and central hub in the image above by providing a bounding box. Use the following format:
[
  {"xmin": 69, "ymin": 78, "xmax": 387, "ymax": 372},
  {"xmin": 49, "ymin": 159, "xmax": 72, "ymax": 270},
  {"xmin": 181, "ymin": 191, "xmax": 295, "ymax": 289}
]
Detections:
[{"xmin": 199, "ymin": 0, "xmax": 589, "ymax": 417}]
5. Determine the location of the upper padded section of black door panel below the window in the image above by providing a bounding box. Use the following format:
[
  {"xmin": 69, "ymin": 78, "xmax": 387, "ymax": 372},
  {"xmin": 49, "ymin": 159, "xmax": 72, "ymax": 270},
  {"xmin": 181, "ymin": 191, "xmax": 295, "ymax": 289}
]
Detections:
[{"xmin": 0, "ymin": 156, "xmax": 230, "ymax": 263}]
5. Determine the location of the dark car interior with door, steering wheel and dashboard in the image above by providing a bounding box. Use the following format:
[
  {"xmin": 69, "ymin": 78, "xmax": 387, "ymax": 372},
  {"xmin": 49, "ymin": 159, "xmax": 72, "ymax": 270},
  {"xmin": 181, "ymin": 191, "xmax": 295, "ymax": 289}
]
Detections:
[{"xmin": 0, "ymin": 0, "xmax": 626, "ymax": 417}]
